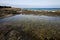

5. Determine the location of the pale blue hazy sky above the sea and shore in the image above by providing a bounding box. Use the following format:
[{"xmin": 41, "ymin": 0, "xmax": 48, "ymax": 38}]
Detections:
[{"xmin": 0, "ymin": 0, "xmax": 60, "ymax": 8}]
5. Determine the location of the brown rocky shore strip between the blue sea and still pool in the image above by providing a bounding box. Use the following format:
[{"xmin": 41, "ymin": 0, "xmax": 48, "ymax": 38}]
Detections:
[{"xmin": 0, "ymin": 6, "xmax": 60, "ymax": 17}]
